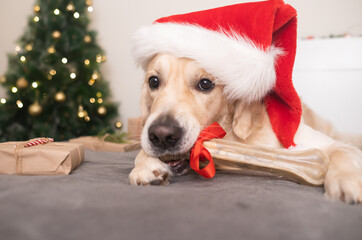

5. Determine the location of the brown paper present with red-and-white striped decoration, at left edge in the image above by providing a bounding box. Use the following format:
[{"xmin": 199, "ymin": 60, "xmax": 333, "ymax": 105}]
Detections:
[{"xmin": 0, "ymin": 142, "xmax": 84, "ymax": 175}]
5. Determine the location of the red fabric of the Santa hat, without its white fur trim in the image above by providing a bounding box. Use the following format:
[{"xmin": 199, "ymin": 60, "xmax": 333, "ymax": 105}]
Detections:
[{"xmin": 155, "ymin": 0, "xmax": 302, "ymax": 148}]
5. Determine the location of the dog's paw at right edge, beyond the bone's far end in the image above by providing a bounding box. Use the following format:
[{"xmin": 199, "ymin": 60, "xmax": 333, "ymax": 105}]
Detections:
[{"xmin": 324, "ymin": 170, "xmax": 362, "ymax": 204}]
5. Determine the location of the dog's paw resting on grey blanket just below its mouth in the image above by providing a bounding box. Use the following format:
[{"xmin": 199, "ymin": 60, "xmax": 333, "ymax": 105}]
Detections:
[{"xmin": 129, "ymin": 161, "xmax": 172, "ymax": 186}]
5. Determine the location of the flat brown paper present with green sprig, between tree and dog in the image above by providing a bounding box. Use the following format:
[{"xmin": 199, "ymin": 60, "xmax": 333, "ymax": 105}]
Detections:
[{"xmin": 69, "ymin": 137, "xmax": 139, "ymax": 152}]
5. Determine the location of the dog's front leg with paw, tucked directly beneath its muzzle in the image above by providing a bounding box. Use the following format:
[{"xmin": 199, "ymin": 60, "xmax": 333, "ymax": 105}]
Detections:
[{"xmin": 129, "ymin": 149, "xmax": 172, "ymax": 186}]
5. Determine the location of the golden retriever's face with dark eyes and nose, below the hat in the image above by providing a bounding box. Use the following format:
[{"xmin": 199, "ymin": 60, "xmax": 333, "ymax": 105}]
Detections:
[{"xmin": 141, "ymin": 54, "xmax": 229, "ymax": 156}]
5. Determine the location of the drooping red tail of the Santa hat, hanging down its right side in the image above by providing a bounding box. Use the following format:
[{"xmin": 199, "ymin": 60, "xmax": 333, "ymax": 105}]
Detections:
[{"xmin": 265, "ymin": 2, "xmax": 302, "ymax": 148}]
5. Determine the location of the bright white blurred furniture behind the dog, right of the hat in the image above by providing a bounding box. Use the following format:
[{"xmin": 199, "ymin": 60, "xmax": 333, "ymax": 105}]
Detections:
[{"xmin": 293, "ymin": 37, "xmax": 362, "ymax": 134}]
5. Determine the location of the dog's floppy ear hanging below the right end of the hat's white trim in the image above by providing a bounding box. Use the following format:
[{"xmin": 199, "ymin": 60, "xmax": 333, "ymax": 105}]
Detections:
[{"xmin": 232, "ymin": 100, "xmax": 253, "ymax": 140}]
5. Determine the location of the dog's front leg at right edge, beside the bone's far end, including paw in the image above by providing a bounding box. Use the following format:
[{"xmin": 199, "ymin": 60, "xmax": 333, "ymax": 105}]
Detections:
[{"xmin": 324, "ymin": 143, "xmax": 362, "ymax": 203}]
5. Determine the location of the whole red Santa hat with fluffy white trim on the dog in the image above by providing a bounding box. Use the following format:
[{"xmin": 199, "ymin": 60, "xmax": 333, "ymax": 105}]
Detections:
[{"xmin": 133, "ymin": 0, "xmax": 301, "ymax": 148}]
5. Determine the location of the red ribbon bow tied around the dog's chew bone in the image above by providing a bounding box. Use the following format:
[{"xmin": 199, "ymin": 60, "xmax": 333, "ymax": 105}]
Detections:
[{"xmin": 190, "ymin": 122, "xmax": 226, "ymax": 178}]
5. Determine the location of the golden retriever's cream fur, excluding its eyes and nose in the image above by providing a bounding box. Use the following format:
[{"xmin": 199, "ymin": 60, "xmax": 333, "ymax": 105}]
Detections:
[{"xmin": 129, "ymin": 54, "xmax": 362, "ymax": 203}]
